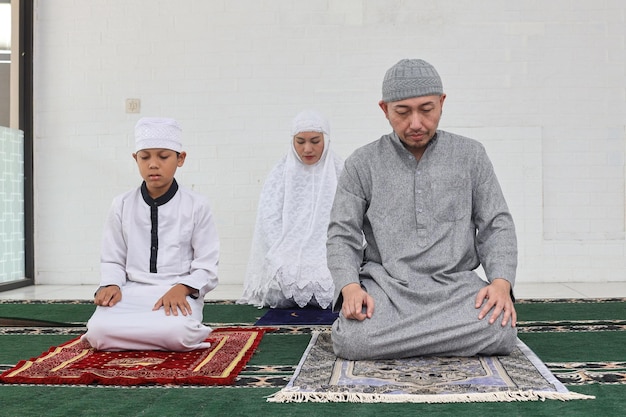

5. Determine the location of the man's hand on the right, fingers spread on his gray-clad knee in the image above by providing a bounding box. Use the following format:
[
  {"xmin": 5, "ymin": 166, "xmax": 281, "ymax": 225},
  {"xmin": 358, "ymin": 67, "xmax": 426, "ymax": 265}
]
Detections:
[{"xmin": 475, "ymin": 278, "xmax": 517, "ymax": 327}]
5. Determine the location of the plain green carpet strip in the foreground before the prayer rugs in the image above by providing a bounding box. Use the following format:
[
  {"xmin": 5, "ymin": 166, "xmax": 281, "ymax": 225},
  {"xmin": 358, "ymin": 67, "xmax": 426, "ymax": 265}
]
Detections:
[{"xmin": 0, "ymin": 385, "xmax": 626, "ymax": 417}]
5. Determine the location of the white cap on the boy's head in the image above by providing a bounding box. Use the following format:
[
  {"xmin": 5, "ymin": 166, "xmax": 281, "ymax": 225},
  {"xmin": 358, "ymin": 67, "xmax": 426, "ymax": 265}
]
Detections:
[{"xmin": 135, "ymin": 117, "xmax": 183, "ymax": 152}]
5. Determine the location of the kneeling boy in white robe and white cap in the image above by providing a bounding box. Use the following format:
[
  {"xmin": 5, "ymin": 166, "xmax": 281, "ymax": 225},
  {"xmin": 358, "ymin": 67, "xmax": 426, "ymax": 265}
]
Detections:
[{"xmin": 83, "ymin": 118, "xmax": 219, "ymax": 351}]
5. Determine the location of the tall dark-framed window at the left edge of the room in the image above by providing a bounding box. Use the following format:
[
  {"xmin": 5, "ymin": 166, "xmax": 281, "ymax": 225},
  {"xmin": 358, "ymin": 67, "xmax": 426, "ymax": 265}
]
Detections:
[{"xmin": 0, "ymin": 0, "xmax": 34, "ymax": 291}]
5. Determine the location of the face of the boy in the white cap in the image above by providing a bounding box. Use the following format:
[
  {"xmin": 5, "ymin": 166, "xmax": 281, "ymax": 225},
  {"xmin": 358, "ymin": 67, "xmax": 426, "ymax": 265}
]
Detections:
[{"xmin": 133, "ymin": 149, "xmax": 187, "ymax": 198}]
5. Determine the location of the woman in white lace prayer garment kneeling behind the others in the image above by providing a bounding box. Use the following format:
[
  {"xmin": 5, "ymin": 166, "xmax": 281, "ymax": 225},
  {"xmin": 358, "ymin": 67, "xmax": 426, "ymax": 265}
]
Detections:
[{"xmin": 239, "ymin": 110, "xmax": 343, "ymax": 308}]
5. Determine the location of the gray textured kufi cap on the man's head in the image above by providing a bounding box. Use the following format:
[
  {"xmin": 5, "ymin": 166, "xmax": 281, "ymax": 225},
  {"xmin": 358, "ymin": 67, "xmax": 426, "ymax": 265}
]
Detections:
[{"xmin": 383, "ymin": 59, "xmax": 443, "ymax": 103}]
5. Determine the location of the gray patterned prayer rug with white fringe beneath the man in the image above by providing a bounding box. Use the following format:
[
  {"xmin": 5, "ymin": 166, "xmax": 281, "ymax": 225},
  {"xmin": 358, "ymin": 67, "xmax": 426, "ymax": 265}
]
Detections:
[{"xmin": 267, "ymin": 332, "xmax": 594, "ymax": 403}]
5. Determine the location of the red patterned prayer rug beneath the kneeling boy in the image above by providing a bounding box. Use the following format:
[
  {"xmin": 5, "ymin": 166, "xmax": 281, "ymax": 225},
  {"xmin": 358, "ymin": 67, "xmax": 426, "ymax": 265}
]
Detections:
[{"xmin": 0, "ymin": 327, "xmax": 271, "ymax": 385}]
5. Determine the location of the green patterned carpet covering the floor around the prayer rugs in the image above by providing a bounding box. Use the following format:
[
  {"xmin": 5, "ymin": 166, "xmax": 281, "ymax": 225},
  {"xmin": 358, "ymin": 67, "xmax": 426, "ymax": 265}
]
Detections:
[{"xmin": 0, "ymin": 300, "xmax": 626, "ymax": 417}]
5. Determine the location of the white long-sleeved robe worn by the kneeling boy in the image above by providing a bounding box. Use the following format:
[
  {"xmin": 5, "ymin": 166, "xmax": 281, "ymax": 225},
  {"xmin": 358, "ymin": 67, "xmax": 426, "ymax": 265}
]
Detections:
[{"xmin": 83, "ymin": 183, "xmax": 219, "ymax": 351}]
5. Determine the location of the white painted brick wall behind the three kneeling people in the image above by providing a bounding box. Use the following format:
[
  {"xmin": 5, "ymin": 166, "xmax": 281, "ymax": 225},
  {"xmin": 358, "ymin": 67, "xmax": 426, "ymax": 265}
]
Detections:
[{"xmin": 35, "ymin": 0, "xmax": 626, "ymax": 285}]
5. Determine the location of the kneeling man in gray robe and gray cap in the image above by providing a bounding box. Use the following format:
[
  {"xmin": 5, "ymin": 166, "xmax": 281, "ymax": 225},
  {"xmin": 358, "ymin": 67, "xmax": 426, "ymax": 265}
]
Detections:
[{"xmin": 327, "ymin": 60, "xmax": 517, "ymax": 360}]
